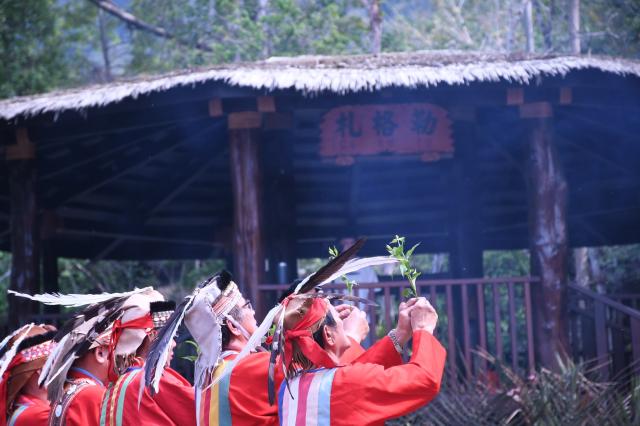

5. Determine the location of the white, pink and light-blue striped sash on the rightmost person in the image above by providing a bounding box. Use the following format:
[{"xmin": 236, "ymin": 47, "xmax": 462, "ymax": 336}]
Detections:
[{"xmin": 278, "ymin": 368, "xmax": 336, "ymax": 426}]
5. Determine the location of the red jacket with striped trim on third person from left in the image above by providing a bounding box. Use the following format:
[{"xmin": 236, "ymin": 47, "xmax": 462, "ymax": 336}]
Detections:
[{"xmin": 100, "ymin": 367, "xmax": 196, "ymax": 426}]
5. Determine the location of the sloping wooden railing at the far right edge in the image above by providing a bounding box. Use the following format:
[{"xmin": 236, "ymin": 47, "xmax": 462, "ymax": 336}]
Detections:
[{"xmin": 569, "ymin": 284, "xmax": 640, "ymax": 380}]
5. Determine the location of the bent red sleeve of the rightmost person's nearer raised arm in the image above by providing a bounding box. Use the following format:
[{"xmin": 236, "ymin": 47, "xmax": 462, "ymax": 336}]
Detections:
[{"xmin": 331, "ymin": 331, "xmax": 446, "ymax": 426}]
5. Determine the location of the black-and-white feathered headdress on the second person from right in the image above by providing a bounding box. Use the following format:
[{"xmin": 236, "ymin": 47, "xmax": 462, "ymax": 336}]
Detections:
[{"xmin": 144, "ymin": 271, "xmax": 242, "ymax": 394}]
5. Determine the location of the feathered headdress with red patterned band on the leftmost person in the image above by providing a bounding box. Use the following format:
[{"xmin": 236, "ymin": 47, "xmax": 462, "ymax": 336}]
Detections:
[{"xmin": 0, "ymin": 323, "xmax": 55, "ymax": 426}]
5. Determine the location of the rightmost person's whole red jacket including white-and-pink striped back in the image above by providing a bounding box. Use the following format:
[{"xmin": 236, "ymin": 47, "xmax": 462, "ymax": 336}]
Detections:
[{"xmin": 278, "ymin": 331, "xmax": 446, "ymax": 426}]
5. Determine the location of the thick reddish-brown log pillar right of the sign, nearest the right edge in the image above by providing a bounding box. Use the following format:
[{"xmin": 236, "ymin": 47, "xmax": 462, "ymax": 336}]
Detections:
[{"xmin": 520, "ymin": 102, "xmax": 569, "ymax": 368}]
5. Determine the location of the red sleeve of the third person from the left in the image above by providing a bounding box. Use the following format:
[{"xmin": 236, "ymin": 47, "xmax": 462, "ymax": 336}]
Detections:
[{"xmin": 151, "ymin": 368, "xmax": 196, "ymax": 426}]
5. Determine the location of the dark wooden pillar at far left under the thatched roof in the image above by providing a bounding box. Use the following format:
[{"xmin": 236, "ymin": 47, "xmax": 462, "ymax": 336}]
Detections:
[{"xmin": 6, "ymin": 128, "xmax": 39, "ymax": 328}]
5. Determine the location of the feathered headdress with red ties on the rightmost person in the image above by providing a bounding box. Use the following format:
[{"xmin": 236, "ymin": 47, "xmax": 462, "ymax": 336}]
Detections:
[{"xmin": 211, "ymin": 239, "xmax": 397, "ymax": 404}]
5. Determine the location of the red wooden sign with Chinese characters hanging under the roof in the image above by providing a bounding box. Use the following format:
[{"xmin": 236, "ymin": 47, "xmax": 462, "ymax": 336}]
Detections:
[{"xmin": 320, "ymin": 103, "xmax": 453, "ymax": 164}]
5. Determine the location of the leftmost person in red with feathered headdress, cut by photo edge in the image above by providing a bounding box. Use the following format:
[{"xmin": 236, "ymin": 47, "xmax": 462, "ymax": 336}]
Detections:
[{"xmin": 0, "ymin": 324, "xmax": 55, "ymax": 426}]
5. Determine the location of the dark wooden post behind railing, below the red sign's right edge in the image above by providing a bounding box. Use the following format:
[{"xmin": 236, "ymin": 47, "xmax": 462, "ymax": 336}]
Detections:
[{"xmin": 449, "ymin": 110, "xmax": 486, "ymax": 377}]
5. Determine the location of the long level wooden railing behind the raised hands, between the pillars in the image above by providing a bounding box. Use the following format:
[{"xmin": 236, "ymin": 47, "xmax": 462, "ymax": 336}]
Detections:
[{"xmin": 258, "ymin": 277, "xmax": 537, "ymax": 382}]
